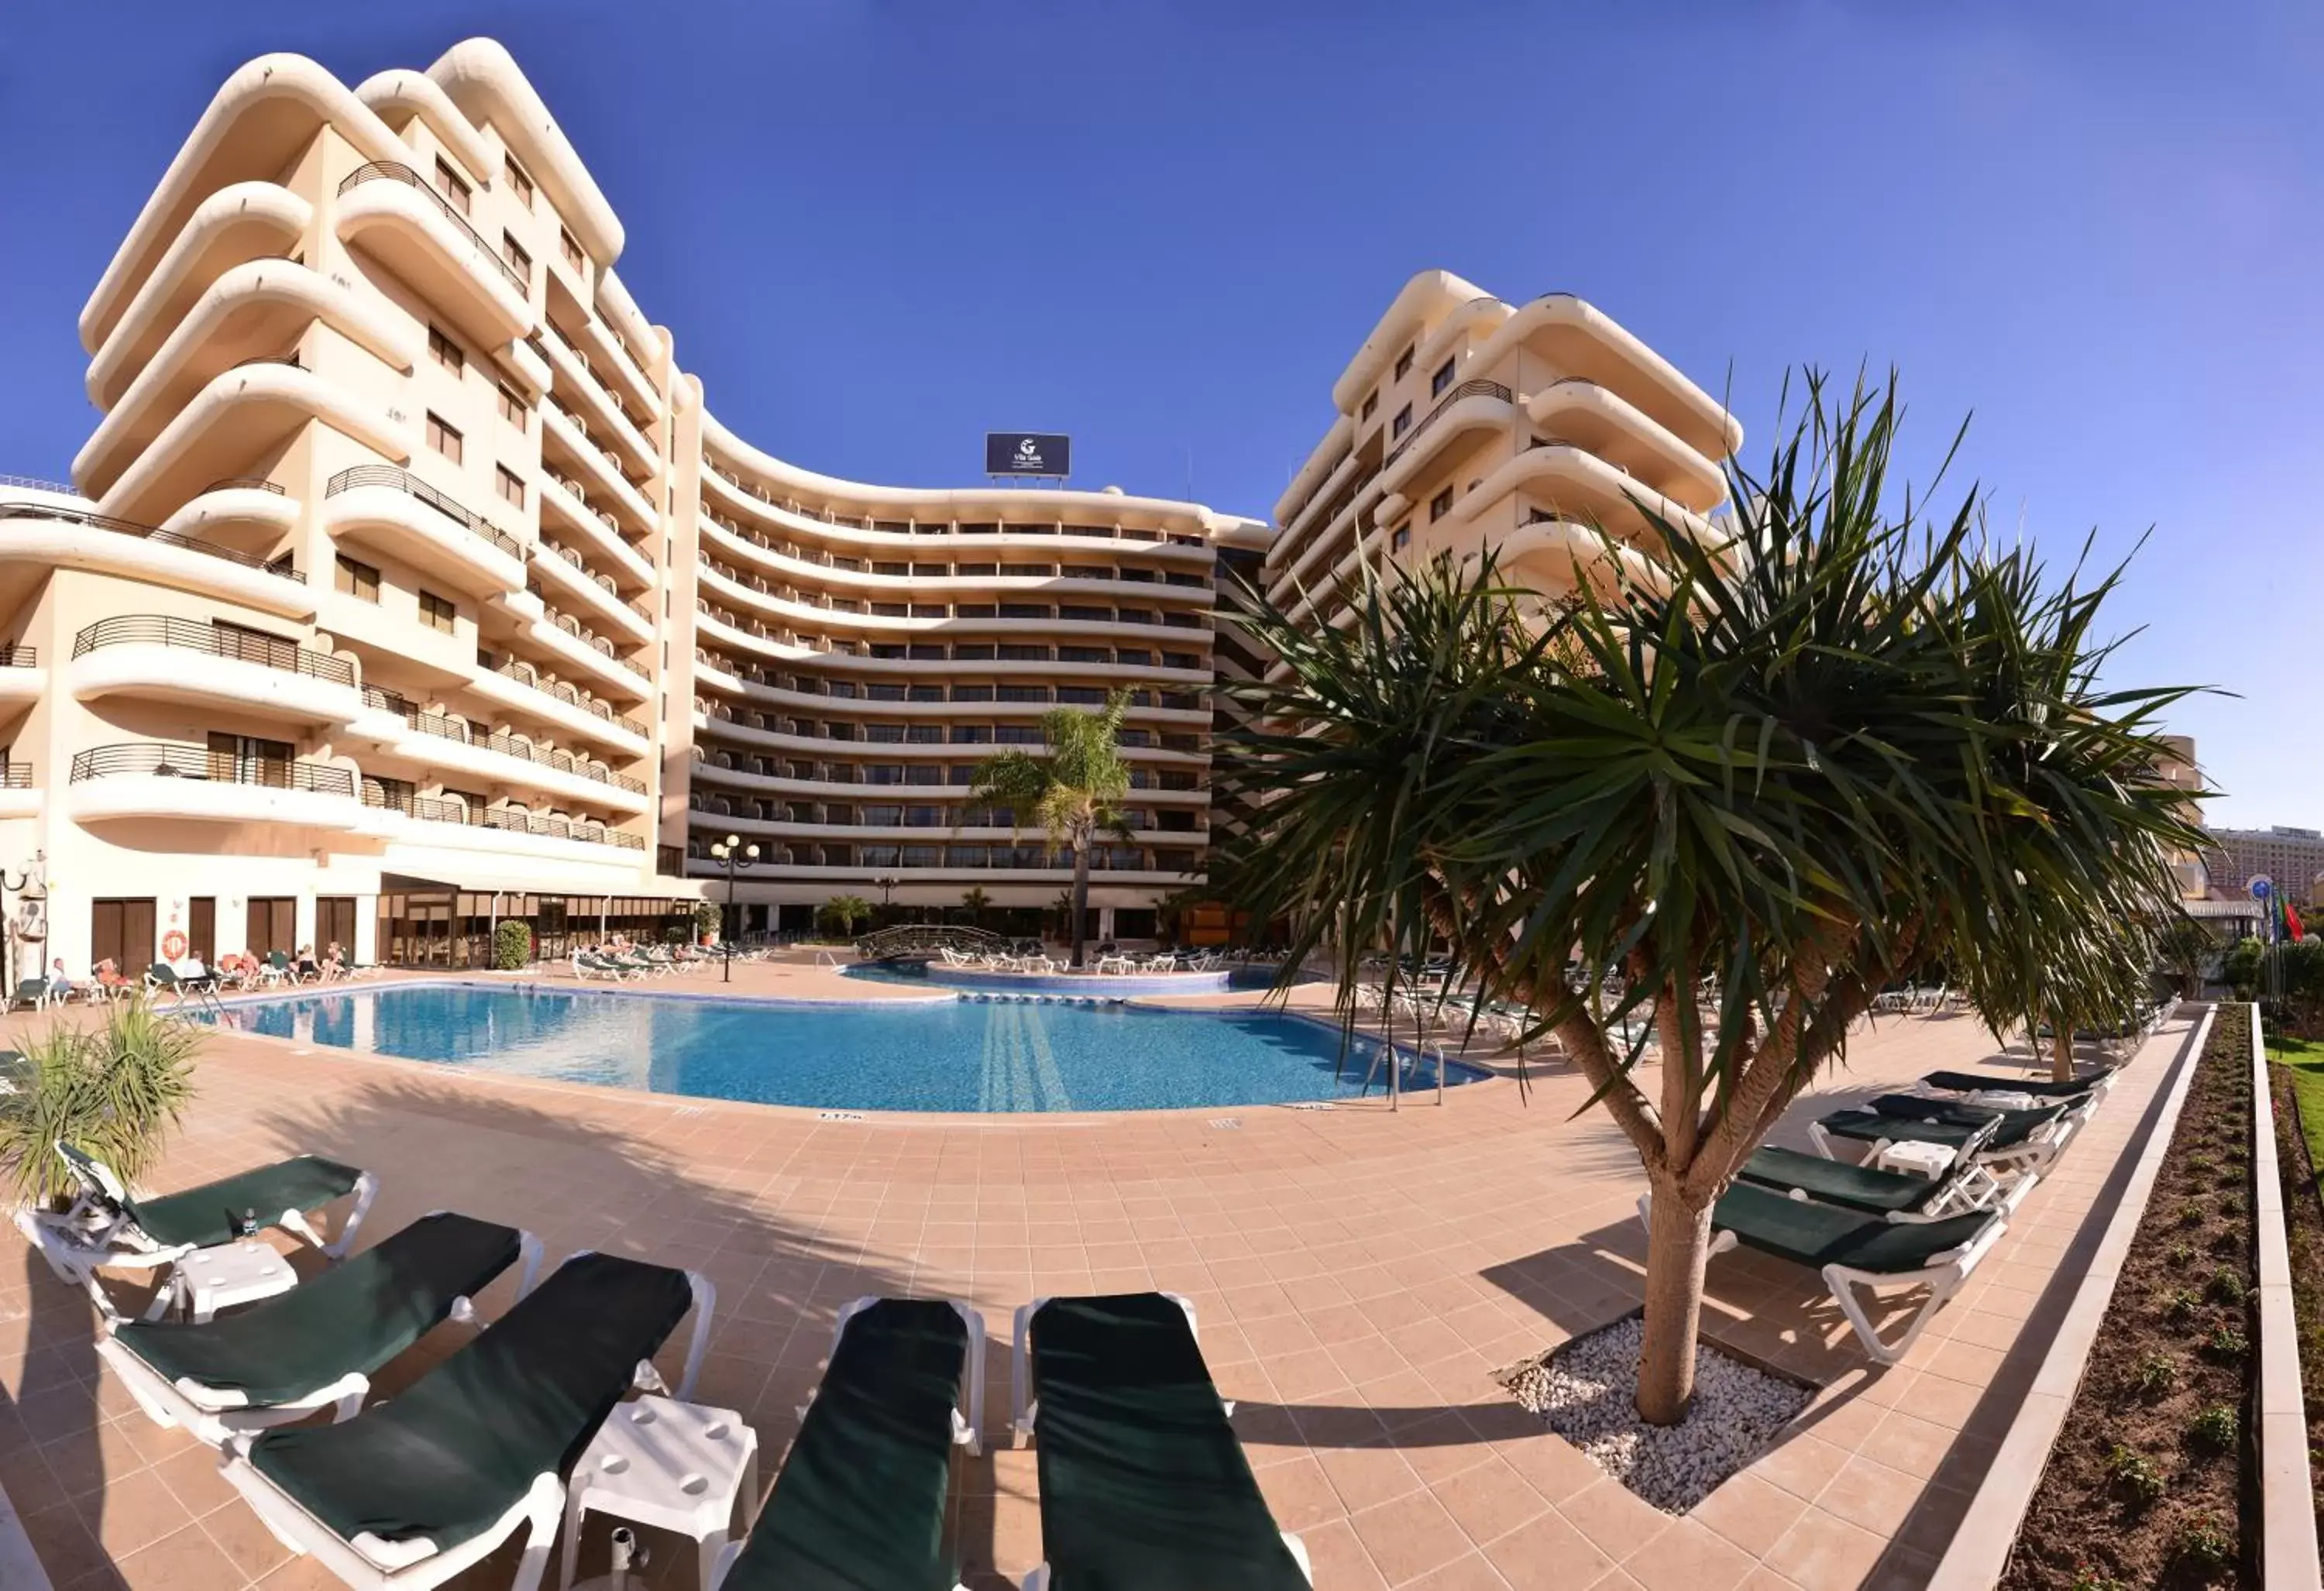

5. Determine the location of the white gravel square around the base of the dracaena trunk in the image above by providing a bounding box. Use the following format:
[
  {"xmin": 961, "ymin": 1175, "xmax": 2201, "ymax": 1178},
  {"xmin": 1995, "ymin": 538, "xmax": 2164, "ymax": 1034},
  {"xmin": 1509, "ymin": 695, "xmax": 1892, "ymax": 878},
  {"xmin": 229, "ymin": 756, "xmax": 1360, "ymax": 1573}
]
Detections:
[{"xmin": 1508, "ymin": 1314, "xmax": 1815, "ymax": 1514}]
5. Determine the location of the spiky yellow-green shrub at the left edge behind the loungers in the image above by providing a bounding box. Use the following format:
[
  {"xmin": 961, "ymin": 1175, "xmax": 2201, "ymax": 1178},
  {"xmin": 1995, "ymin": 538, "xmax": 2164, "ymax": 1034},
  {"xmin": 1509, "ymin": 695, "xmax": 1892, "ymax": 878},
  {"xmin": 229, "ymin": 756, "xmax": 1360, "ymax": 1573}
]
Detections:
[{"xmin": 0, "ymin": 1001, "xmax": 202, "ymax": 1208}]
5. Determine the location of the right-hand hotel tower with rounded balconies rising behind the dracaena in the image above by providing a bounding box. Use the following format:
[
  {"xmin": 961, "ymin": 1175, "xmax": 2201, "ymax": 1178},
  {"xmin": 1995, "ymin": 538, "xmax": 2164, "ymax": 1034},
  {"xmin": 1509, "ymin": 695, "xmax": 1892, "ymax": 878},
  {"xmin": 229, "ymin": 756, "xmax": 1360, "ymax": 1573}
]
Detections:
[{"xmin": 1264, "ymin": 272, "xmax": 1743, "ymax": 650}]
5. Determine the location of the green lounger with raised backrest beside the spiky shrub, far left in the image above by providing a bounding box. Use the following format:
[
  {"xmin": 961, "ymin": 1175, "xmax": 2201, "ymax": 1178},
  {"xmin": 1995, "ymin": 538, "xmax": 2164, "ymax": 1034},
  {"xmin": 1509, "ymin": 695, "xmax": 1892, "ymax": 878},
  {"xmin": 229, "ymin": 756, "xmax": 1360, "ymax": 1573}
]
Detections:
[{"xmin": 16, "ymin": 1143, "xmax": 379, "ymax": 1319}]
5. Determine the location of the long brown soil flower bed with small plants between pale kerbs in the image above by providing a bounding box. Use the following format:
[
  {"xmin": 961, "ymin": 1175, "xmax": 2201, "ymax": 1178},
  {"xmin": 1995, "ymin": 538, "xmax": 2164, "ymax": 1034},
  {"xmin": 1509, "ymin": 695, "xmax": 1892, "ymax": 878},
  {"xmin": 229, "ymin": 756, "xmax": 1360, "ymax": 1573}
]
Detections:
[{"xmin": 2001, "ymin": 1005, "xmax": 2259, "ymax": 1591}]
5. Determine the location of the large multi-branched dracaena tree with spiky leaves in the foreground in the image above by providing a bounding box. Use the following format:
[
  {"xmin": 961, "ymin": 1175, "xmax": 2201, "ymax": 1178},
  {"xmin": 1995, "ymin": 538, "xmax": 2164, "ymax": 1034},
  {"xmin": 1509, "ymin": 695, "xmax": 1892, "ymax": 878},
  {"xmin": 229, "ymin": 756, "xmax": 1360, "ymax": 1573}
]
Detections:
[{"xmin": 1213, "ymin": 376, "xmax": 2194, "ymax": 1424}]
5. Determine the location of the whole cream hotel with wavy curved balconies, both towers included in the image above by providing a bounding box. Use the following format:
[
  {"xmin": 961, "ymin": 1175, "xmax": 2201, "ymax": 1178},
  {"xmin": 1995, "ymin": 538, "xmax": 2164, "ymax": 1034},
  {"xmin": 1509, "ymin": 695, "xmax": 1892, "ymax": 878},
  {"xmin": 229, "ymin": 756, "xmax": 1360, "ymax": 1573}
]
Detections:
[{"xmin": 0, "ymin": 40, "xmax": 1734, "ymax": 975}]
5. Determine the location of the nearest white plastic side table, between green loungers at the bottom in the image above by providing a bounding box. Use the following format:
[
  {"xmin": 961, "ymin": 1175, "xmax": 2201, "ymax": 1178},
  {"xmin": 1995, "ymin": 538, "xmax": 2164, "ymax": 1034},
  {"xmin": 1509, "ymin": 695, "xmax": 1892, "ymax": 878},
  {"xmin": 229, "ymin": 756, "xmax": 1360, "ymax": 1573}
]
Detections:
[{"xmin": 558, "ymin": 1398, "xmax": 758, "ymax": 1591}]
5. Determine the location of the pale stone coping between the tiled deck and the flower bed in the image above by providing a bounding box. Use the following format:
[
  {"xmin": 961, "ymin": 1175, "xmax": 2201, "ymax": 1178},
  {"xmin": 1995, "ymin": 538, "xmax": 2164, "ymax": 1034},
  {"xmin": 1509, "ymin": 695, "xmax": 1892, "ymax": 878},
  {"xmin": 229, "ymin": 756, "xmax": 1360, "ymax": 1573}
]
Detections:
[{"xmin": 1929, "ymin": 1005, "xmax": 2212, "ymax": 1591}]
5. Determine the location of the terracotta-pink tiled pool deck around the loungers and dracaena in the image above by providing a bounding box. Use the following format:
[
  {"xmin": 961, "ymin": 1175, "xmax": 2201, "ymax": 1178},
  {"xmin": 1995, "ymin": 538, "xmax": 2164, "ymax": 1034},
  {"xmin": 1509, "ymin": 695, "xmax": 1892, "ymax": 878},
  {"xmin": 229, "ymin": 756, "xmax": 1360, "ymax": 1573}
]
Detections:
[{"xmin": 0, "ymin": 966, "xmax": 2187, "ymax": 1591}]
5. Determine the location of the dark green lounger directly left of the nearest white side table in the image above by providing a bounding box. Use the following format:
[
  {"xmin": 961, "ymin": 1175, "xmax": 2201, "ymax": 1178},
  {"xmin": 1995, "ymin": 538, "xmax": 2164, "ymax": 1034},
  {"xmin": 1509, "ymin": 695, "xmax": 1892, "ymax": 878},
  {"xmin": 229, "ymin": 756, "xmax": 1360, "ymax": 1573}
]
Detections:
[{"xmin": 223, "ymin": 1252, "xmax": 713, "ymax": 1591}]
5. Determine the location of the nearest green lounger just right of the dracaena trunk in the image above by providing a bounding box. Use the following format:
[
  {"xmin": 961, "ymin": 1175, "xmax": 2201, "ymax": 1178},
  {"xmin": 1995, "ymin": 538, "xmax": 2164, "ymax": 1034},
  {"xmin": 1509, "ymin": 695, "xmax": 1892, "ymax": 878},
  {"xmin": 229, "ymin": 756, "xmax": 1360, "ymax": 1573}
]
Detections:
[{"xmin": 1638, "ymin": 1182, "xmax": 2008, "ymax": 1363}]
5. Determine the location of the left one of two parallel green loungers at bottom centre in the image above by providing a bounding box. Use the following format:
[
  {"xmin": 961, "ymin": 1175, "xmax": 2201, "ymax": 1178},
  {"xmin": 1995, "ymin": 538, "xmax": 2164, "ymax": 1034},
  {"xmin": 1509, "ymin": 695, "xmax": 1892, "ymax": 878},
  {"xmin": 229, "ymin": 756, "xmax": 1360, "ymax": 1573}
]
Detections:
[{"xmin": 711, "ymin": 1298, "xmax": 985, "ymax": 1591}]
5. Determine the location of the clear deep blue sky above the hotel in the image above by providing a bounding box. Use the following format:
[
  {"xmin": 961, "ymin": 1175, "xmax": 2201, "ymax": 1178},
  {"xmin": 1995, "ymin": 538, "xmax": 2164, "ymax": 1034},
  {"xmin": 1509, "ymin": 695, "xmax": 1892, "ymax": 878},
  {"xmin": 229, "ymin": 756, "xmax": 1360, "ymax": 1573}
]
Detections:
[{"xmin": 0, "ymin": 0, "xmax": 2324, "ymax": 824}]
